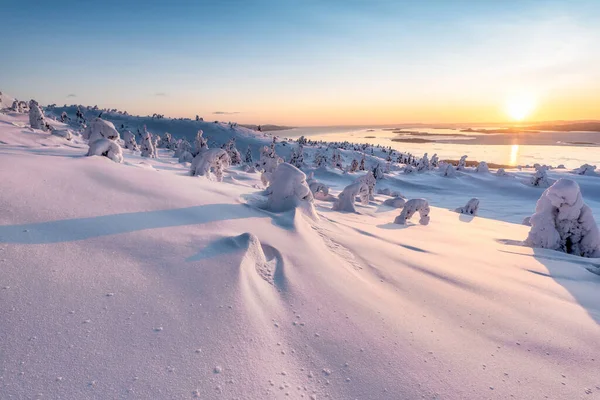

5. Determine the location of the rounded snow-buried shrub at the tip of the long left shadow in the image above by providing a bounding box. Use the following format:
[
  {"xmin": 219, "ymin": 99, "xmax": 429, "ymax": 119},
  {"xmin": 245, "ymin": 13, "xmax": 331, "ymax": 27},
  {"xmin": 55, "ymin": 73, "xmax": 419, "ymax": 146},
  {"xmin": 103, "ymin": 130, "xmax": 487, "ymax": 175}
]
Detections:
[{"xmin": 267, "ymin": 163, "xmax": 314, "ymax": 212}]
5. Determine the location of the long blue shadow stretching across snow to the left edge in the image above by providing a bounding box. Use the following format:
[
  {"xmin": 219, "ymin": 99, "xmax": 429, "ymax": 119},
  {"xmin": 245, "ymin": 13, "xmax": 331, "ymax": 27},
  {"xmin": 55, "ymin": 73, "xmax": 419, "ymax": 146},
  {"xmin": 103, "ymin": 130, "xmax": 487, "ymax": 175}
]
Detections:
[{"xmin": 0, "ymin": 204, "xmax": 268, "ymax": 244}]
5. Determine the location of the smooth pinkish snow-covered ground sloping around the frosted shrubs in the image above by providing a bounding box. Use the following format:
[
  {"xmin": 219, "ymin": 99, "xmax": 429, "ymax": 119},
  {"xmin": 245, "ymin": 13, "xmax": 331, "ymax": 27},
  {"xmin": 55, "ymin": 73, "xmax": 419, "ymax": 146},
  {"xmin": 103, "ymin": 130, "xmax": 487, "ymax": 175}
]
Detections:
[{"xmin": 0, "ymin": 109, "xmax": 600, "ymax": 399}]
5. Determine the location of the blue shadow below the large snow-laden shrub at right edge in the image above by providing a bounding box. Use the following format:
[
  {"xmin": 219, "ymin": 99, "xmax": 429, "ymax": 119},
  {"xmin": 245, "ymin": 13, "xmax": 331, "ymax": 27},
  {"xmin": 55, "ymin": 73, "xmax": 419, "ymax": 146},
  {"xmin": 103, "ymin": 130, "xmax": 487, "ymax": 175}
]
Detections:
[{"xmin": 531, "ymin": 249, "xmax": 600, "ymax": 325}]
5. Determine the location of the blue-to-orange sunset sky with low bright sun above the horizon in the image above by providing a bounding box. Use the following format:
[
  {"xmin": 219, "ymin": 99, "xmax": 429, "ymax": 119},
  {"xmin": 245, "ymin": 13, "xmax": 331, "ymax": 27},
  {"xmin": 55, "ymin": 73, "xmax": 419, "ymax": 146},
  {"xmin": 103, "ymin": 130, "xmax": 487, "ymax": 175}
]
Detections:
[{"xmin": 0, "ymin": 0, "xmax": 600, "ymax": 126}]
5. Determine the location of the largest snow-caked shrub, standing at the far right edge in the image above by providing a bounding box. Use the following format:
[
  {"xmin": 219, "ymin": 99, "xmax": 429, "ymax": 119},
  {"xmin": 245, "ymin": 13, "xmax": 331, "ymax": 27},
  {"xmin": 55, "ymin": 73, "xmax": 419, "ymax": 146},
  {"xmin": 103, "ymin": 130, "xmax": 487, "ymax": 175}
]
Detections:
[{"xmin": 525, "ymin": 178, "xmax": 600, "ymax": 257}]
